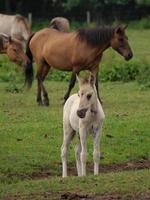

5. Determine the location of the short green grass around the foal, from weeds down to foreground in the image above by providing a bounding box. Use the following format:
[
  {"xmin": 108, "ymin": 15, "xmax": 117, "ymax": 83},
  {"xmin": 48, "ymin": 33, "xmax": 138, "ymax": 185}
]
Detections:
[{"xmin": 0, "ymin": 82, "xmax": 150, "ymax": 199}]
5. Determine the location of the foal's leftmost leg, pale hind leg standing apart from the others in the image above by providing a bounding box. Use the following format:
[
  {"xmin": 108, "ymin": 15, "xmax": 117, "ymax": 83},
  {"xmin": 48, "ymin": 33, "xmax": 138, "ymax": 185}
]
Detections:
[{"xmin": 61, "ymin": 125, "xmax": 75, "ymax": 177}]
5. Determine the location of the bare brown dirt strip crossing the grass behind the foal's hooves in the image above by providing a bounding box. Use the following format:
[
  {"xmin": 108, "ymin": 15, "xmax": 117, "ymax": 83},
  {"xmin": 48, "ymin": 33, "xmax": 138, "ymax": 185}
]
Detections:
[{"xmin": 4, "ymin": 160, "xmax": 150, "ymax": 180}]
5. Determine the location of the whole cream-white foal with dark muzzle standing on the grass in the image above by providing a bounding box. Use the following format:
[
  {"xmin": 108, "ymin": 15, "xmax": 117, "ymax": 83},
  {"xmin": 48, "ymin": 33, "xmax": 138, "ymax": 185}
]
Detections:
[{"xmin": 61, "ymin": 74, "xmax": 105, "ymax": 177}]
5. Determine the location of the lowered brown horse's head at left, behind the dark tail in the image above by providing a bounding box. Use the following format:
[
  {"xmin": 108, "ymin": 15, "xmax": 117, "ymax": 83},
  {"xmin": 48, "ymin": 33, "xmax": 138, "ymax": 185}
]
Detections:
[{"xmin": 6, "ymin": 37, "xmax": 30, "ymax": 66}]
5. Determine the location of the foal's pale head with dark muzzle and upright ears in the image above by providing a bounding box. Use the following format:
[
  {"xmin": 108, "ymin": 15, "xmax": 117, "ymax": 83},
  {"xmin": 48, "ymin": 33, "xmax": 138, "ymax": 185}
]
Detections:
[{"xmin": 77, "ymin": 74, "xmax": 97, "ymax": 118}]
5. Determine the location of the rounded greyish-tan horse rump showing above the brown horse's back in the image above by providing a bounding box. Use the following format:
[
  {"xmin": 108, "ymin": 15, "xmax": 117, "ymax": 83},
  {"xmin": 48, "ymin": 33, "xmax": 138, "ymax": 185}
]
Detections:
[{"xmin": 49, "ymin": 17, "xmax": 70, "ymax": 33}]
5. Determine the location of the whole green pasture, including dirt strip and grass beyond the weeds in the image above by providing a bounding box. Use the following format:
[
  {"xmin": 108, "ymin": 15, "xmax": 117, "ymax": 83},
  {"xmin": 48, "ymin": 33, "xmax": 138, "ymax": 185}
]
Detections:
[{"xmin": 0, "ymin": 27, "xmax": 150, "ymax": 200}]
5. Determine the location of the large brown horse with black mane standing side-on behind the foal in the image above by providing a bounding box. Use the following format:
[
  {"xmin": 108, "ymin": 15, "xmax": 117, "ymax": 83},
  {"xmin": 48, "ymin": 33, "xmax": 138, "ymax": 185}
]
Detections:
[{"xmin": 26, "ymin": 27, "xmax": 133, "ymax": 105}]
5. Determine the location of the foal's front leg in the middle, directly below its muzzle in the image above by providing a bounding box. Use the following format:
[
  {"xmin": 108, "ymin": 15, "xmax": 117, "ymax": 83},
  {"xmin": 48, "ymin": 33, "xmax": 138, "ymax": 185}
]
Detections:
[{"xmin": 79, "ymin": 123, "xmax": 87, "ymax": 176}]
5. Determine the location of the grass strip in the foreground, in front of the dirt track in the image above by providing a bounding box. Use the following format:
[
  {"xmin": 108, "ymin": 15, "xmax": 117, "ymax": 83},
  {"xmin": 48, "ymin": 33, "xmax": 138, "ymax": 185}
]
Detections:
[{"xmin": 1, "ymin": 170, "xmax": 150, "ymax": 200}]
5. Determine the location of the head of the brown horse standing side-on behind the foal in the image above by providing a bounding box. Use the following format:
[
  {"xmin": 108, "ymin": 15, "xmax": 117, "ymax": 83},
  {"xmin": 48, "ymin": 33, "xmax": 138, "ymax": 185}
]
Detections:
[{"xmin": 110, "ymin": 26, "xmax": 133, "ymax": 60}]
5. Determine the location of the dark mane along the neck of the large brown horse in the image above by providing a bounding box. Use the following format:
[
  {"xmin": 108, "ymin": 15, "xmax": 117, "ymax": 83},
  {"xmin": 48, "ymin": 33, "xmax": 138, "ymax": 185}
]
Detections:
[{"xmin": 77, "ymin": 27, "xmax": 114, "ymax": 46}]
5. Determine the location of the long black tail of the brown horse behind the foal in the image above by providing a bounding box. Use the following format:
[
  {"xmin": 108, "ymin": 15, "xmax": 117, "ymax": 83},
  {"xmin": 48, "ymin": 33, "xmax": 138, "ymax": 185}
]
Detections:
[{"xmin": 24, "ymin": 33, "xmax": 35, "ymax": 88}]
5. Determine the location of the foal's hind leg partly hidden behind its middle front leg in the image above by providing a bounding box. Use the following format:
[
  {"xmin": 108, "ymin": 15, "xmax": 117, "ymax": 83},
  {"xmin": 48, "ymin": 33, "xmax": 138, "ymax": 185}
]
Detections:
[{"xmin": 75, "ymin": 138, "xmax": 82, "ymax": 176}]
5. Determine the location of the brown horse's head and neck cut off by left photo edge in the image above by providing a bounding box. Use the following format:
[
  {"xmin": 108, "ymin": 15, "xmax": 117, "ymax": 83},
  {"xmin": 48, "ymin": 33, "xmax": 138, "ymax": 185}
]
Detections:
[{"xmin": 0, "ymin": 33, "xmax": 30, "ymax": 76}]
